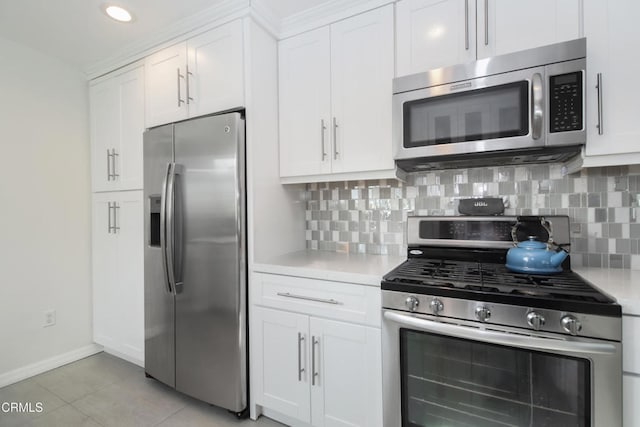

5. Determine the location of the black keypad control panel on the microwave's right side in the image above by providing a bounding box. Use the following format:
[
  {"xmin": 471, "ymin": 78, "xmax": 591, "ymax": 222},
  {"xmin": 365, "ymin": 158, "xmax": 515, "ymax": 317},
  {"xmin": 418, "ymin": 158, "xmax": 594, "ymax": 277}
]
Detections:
[{"xmin": 549, "ymin": 71, "xmax": 584, "ymax": 133}]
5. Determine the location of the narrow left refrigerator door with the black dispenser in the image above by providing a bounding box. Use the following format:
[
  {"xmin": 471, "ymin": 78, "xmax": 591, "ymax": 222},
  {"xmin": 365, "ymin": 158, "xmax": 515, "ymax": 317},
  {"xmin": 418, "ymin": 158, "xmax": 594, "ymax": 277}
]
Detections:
[{"xmin": 143, "ymin": 125, "xmax": 175, "ymax": 387}]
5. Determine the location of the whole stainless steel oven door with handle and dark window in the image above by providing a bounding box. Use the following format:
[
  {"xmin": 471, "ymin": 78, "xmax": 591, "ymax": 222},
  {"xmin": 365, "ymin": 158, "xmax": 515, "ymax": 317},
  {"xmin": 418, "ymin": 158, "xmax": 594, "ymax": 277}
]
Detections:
[{"xmin": 383, "ymin": 310, "xmax": 622, "ymax": 427}]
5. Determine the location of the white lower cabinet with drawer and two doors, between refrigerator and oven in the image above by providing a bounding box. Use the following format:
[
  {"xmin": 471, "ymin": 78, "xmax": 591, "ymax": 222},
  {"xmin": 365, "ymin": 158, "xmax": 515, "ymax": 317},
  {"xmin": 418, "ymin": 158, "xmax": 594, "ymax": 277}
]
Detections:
[{"xmin": 250, "ymin": 274, "xmax": 382, "ymax": 427}]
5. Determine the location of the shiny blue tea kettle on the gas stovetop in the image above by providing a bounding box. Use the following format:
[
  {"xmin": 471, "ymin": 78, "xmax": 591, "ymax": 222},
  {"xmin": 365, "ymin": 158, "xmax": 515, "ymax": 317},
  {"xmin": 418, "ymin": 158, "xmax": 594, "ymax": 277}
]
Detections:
[{"xmin": 506, "ymin": 236, "xmax": 569, "ymax": 274}]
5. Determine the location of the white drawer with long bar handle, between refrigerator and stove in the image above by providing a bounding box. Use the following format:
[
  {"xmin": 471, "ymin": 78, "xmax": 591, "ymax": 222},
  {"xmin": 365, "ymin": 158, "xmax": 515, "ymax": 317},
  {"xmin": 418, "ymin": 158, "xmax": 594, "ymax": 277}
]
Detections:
[{"xmin": 250, "ymin": 273, "xmax": 381, "ymax": 327}]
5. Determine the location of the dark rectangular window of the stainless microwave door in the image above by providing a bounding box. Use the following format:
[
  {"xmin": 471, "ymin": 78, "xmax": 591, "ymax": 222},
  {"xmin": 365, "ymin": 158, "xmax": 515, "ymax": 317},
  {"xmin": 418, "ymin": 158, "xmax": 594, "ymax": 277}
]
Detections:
[{"xmin": 403, "ymin": 81, "xmax": 529, "ymax": 148}]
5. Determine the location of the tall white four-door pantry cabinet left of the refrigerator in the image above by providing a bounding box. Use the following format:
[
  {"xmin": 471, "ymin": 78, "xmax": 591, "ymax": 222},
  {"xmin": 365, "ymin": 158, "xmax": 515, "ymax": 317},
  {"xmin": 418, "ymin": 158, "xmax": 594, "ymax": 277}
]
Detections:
[{"xmin": 89, "ymin": 65, "xmax": 144, "ymax": 365}]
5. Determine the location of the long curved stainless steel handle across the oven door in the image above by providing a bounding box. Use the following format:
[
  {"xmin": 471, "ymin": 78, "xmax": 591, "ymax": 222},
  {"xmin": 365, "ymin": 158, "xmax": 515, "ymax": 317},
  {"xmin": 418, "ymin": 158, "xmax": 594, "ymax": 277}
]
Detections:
[{"xmin": 384, "ymin": 311, "xmax": 617, "ymax": 354}]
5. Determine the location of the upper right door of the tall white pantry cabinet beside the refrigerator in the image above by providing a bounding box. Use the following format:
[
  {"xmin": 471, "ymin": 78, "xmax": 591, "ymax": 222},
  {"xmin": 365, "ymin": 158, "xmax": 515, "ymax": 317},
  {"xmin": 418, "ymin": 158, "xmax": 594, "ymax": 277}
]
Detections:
[{"xmin": 114, "ymin": 67, "xmax": 144, "ymax": 190}]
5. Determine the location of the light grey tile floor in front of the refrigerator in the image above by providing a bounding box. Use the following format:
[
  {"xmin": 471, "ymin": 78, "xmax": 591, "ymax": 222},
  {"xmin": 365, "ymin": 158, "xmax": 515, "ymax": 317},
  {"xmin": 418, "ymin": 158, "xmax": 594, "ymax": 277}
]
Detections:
[{"xmin": 0, "ymin": 353, "xmax": 281, "ymax": 427}]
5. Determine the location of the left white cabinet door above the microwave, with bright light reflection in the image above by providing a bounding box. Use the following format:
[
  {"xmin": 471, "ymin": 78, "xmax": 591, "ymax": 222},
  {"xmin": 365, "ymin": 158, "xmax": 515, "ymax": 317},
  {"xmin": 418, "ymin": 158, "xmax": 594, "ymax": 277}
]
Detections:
[{"xmin": 396, "ymin": 0, "xmax": 476, "ymax": 76}]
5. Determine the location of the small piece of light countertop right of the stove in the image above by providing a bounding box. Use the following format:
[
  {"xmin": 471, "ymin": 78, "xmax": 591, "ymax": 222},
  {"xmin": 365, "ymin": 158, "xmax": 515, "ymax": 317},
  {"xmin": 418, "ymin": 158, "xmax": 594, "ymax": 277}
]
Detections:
[{"xmin": 573, "ymin": 267, "xmax": 640, "ymax": 316}]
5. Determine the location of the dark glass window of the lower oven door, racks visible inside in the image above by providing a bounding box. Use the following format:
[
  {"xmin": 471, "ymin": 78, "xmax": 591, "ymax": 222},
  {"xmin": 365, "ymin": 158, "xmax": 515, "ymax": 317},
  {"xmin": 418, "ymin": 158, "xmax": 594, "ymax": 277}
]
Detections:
[{"xmin": 400, "ymin": 329, "xmax": 591, "ymax": 427}]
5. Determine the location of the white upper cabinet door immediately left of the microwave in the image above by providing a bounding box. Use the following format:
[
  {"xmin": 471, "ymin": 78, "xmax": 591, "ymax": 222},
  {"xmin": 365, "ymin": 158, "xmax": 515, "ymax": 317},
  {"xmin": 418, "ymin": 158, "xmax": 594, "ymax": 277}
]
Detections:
[{"xmin": 330, "ymin": 5, "xmax": 394, "ymax": 173}]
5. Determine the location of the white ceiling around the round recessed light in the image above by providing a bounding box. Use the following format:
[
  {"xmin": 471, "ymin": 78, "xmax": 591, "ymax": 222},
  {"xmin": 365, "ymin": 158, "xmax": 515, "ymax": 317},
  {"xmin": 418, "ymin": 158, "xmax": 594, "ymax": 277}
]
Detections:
[{"xmin": 0, "ymin": 0, "xmax": 329, "ymax": 75}]
